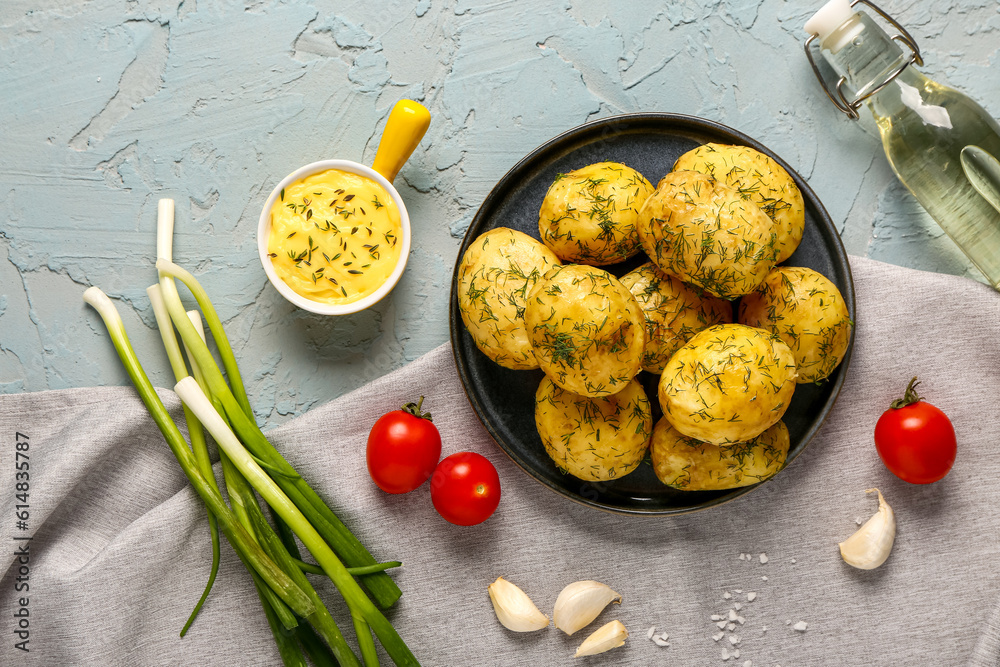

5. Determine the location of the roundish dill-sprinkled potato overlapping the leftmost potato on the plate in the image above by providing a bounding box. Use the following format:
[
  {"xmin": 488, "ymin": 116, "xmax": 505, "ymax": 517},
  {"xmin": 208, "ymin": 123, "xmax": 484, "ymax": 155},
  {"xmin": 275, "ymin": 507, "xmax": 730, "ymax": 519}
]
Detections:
[{"xmin": 524, "ymin": 264, "xmax": 646, "ymax": 396}]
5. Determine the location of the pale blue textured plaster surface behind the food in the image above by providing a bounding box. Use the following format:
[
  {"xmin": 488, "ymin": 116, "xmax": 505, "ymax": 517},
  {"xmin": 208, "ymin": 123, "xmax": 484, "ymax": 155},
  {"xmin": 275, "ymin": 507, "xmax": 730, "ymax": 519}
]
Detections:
[{"xmin": 0, "ymin": 0, "xmax": 1000, "ymax": 424}]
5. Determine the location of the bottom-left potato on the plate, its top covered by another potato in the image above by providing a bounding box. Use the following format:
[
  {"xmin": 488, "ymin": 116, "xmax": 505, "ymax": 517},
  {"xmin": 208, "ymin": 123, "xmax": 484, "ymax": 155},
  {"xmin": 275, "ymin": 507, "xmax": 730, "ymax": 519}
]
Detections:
[{"xmin": 535, "ymin": 377, "xmax": 653, "ymax": 482}]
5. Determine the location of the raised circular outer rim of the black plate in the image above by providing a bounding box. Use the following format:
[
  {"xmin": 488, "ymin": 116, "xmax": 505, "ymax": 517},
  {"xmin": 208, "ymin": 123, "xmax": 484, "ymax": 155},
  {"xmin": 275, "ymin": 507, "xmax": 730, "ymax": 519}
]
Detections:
[{"xmin": 448, "ymin": 111, "xmax": 857, "ymax": 517}]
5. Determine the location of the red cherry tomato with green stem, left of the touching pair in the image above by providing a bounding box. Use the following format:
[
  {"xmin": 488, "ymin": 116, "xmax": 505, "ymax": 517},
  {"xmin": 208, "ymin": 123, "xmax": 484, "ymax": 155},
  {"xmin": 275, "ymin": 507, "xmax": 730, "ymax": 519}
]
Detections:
[{"xmin": 367, "ymin": 396, "xmax": 441, "ymax": 493}]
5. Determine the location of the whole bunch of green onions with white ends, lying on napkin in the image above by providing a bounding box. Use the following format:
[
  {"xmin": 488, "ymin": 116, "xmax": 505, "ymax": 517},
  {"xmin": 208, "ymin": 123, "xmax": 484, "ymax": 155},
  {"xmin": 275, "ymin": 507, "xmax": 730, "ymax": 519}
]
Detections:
[{"xmin": 84, "ymin": 200, "xmax": 419, "ymax": 667}]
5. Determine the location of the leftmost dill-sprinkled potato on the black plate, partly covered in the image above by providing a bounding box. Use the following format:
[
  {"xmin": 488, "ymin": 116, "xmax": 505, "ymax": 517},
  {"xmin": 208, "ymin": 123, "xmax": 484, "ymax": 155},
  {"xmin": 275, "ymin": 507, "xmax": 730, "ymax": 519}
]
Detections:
[{"xmin": 458, "ymin": 227, "xmax": 559, "ymax": 370}]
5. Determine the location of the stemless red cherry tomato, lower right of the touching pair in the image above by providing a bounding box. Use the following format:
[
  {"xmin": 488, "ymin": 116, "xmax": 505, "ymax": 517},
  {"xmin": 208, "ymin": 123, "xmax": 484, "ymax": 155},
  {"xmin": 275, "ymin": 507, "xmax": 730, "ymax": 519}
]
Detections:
[{"xmin": 431, "ymin": 452, "xmax": 500, "ymax": 526}]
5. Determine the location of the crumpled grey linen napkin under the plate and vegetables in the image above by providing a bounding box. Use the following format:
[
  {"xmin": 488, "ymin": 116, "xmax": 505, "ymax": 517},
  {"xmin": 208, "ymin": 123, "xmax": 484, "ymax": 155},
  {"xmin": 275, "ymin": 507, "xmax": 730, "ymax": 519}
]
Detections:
[{"xmin": 0, "ymin": 253, "xmax": 1000, "ymax": 667}]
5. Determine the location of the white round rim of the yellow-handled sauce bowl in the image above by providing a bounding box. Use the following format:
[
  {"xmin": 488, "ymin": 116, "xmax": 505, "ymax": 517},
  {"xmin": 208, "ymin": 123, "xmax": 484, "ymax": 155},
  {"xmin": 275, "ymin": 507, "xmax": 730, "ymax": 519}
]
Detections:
[{"xmin": 257, "ymin": 160, "xmax": 410, "ymax": 315}]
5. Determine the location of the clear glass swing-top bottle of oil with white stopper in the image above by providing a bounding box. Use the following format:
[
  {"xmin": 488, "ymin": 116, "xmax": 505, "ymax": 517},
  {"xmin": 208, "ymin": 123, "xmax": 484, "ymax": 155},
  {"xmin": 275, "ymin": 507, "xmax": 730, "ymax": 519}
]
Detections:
[{"xmin": 806, "ymin": 0, "xmax": 1000, "ymax": 289}]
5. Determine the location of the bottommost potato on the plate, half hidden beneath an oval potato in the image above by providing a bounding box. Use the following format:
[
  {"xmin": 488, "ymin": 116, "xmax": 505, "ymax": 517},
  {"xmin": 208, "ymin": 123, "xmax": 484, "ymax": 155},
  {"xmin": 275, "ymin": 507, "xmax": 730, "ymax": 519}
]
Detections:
[{"xmin": 651, "ymin": 419, "xmax": 789, "ymax": 491}]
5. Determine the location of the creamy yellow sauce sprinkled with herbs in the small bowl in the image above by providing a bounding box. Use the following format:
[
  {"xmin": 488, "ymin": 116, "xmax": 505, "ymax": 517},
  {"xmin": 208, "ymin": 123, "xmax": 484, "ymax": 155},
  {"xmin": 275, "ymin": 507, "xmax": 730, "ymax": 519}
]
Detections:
[{"xmin": 267, "ymin": 169, "xmax": 402, "ymax": 304}]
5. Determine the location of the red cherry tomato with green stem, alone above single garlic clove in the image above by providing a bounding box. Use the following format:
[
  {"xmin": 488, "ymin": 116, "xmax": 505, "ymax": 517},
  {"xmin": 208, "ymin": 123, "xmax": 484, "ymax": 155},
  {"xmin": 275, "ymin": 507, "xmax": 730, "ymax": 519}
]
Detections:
[{"xmin": 875, "ymin": 378, "xmax": 957, "ymax": 484}]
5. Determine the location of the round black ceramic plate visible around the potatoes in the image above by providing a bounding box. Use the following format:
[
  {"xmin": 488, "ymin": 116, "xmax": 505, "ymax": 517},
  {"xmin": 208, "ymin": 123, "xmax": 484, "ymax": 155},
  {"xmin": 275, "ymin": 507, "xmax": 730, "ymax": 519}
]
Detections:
[{"xmin": 450, "ymin": 113, "xmax": 855, "ymax": 514}]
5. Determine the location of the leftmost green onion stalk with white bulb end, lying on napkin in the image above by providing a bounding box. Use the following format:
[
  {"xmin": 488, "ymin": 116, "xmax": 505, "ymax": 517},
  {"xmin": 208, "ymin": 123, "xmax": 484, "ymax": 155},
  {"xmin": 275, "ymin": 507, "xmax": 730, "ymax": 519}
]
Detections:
[{"xmin": 83, "ymin": 287, "xmax": 315, "ymax": 617}]
